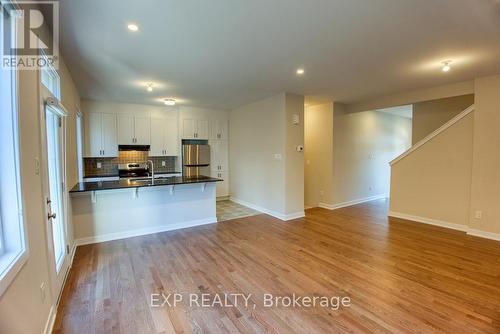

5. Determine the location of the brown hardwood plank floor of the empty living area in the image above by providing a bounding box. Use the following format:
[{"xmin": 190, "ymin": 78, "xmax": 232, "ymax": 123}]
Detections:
[{"xmin": 54, "ymin": 201, "xmax": 500, "ymax": 334}]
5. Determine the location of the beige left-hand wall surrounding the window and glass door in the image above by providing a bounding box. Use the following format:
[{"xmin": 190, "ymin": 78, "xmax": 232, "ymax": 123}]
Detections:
[{"xmin": 0, "ymin": 58, "xmax": 80, "ymax": 334}]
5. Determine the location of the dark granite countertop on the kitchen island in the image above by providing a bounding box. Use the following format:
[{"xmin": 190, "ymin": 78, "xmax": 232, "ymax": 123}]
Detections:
[{"xmin": 69, "ymin": 176, "xmax": 223, "ymax": 193}]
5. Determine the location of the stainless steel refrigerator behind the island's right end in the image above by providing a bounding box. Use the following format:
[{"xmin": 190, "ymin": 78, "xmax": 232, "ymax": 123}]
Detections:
[{"xmin": 182, "ymin": 144, "xmax": 210, "ymax": 176}]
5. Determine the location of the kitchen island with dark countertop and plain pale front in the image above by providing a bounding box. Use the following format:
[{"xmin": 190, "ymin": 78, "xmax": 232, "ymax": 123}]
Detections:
[{"xmin": 70, "ymin": 176, "xmax": 222, "ymax": 245}]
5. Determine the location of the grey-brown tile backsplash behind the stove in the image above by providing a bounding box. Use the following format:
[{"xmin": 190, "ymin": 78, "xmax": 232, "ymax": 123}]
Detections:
[{"xmin": 83, "ymin": 151, "xmax": 177, "ymax": 177}]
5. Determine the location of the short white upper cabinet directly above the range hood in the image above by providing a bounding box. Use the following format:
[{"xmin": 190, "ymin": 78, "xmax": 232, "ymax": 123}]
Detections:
[{"xmin": 118, "ymin": 115, "xmax": 151, "ymax": 145}]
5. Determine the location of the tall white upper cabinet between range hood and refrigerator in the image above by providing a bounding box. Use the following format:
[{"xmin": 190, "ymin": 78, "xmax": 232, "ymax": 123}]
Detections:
[{"xmin": 149, "ymin": 117, "xmax": 179, "ymax": 157}]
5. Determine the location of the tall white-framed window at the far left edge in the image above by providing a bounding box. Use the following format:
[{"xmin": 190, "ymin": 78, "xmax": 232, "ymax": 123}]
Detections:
[{"xmin": 0, "ymin": 1, "xmax": 28, "ymax": 296}]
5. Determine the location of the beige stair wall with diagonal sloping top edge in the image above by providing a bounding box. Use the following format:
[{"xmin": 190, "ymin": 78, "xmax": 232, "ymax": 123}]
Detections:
[{"xmin": 390, "ymin": 114, "xmax": 474, "ymax": 227}]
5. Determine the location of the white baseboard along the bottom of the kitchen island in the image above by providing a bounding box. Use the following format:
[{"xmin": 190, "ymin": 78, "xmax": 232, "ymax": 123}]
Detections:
[{"xmin": 75, "ymin": 217, "xmax": 217, "ymax": 246}]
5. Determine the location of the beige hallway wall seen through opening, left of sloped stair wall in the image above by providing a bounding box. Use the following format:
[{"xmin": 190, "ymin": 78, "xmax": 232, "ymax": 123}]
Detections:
[{"xmin": 327, "ymin": 103, "xmax": 411, "ymax": 206}]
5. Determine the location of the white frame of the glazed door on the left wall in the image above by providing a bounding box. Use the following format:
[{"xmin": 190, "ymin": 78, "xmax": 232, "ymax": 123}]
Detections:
[{"xmin": 39, "ymin": 90, "xmax": 70, "ymax": 304}]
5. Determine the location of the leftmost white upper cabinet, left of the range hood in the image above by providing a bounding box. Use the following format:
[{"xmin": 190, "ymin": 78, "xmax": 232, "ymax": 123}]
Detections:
[{"xmin": 84, "ymin": 113, "xmax": 118, "ymax": 158}]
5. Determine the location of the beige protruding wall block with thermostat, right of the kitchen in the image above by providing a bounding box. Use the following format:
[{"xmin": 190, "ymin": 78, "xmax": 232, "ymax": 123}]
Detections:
[{"xmin": 229, "ymin": 93, "xmax": 304, "ymax": 219}]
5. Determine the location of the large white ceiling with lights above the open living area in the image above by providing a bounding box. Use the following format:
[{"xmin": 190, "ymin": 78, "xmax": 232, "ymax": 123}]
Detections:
[{"xmin": 56, "ymin": 0, "xmax": 500, "ymax": 109}]
